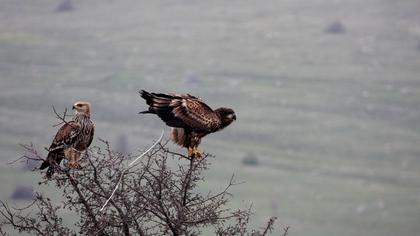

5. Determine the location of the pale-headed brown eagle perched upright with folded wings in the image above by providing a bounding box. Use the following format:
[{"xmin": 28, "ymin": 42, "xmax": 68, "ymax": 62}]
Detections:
[{"xmin": 40, "ymin": 101, "xmax": 95, "ymax": 178}]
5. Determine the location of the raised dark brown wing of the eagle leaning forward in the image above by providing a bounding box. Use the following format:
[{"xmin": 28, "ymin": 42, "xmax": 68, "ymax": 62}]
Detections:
[{"xmin": 140, "ymin": 90, "xmax": 221, "ymax": 132}]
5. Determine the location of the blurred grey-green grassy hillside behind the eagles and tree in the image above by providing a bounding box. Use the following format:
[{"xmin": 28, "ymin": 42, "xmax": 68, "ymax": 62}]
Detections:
[{"xmin": 0, "ymin": 0, "xmax": 420, "ymax": 236}]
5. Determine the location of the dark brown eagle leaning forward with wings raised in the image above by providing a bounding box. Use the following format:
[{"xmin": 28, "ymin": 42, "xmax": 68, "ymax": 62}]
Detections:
[{"xmin": 140, "ymin": 90, "xmax": 236, "ymax": 158}]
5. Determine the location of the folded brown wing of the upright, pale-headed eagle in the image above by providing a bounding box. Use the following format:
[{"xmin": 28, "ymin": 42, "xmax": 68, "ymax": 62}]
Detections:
[{"xmin": 49, "ymin": 121, "xmax": 80, "ymax": 152}]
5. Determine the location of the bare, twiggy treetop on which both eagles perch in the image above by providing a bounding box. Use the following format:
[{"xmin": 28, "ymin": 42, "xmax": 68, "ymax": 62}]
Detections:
[{"xmin": 0, "ymin": 137, "xmax": 282, "ymax": 236}]
